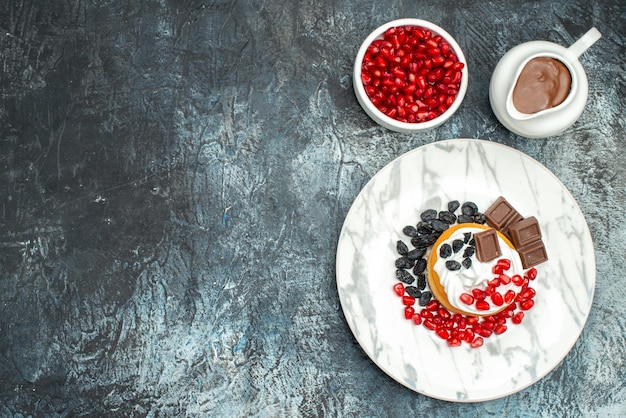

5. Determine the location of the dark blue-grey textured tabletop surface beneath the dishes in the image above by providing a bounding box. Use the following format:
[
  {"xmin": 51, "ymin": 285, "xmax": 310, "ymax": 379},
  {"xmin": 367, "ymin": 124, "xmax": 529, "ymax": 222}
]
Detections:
[{"xmin": 0, "ymin": 0, "xmax": 626, "ymax": 417}]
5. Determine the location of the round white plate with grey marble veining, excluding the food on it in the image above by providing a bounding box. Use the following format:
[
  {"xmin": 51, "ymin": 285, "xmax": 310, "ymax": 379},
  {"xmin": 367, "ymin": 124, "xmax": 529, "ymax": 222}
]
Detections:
[{"xmin": 337, "ymin": 139, "xmax": 596, "ymax": 402}]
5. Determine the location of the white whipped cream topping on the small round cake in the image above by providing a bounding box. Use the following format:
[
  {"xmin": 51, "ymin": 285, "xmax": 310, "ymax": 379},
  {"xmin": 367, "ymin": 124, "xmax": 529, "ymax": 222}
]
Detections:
[{"xmin": 433, "ymin": 227, "xmax": 524, "ymax": 315}]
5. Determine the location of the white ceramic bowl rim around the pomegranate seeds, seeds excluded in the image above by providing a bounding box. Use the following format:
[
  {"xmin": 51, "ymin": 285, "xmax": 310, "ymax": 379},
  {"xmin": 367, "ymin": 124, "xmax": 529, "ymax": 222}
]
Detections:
[{"xmin": 353, "ymin": 18, "xmax": 468, "ymax": 133}]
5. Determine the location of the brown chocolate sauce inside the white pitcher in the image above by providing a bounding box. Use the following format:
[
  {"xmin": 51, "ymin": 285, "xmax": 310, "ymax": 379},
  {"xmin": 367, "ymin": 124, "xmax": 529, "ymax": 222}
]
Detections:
[{"xmin": 513, "ymin": 57, "xmax": 572, "ymax": 114}]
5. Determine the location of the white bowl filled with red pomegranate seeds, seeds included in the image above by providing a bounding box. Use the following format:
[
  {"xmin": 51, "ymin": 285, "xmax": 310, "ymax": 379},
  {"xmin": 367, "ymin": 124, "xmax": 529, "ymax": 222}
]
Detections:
[{"xmin": 353, "ymin": 18, "xmax": 468, "ymax": 133}]
